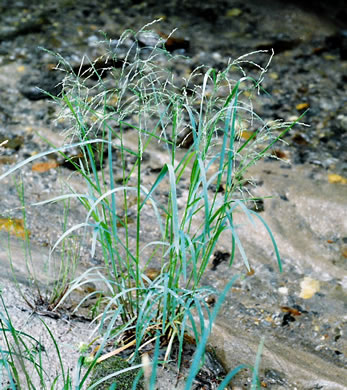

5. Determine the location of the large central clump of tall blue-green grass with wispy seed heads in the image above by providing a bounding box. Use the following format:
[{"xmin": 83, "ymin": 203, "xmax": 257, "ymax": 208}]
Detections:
[{"xmin": 0, "ymin": 25, "xmax": 304, "ymax": 390}]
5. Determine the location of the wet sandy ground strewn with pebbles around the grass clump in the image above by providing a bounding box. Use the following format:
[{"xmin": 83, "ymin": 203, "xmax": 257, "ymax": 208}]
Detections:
[{"xmin": 0, "ymin": 0, "xmax": 347, "ymax": 390}]
